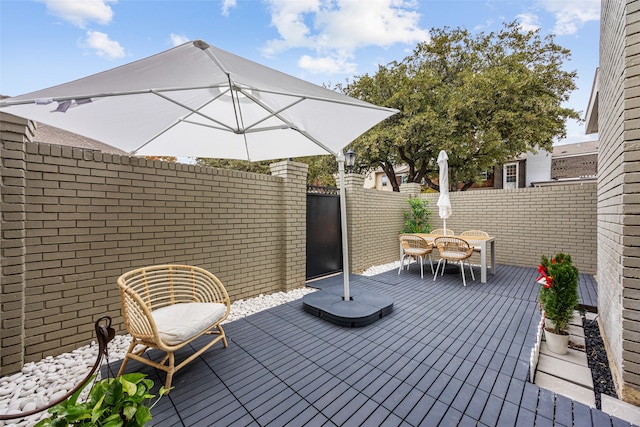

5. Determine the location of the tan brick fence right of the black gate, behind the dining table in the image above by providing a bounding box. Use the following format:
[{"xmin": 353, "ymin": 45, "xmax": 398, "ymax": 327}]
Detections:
[{"xmin": 346, "ymin": 177, "xmax": 597, "ymax": 274}]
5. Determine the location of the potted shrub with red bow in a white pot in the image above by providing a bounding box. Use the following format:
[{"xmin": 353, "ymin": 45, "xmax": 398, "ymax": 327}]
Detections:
[{"xmin": 537, "ymin": 252, "xmax": 579, "ymax": 354}]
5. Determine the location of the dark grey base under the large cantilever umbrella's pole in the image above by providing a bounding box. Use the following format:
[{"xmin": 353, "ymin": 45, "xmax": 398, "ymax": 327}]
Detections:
[{"xmin": 302, "ymin": 286, "xmax": 393, "ymax": 328}]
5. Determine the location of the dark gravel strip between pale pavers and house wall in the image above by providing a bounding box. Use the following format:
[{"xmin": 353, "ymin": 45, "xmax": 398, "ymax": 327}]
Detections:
[{"xmin": 582, "ymin": 316, "xmax": 618, "ymax": 409}]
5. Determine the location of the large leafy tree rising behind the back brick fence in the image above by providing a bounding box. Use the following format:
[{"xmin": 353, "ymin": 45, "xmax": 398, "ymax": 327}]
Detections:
[{"xmin": 337, "ymin": 21, "xmax": 580, "ymax": 191}]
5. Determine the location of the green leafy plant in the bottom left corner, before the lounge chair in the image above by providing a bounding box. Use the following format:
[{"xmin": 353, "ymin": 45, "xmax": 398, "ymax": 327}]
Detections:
[{"xmin": 36, "ymin": 373, "xmax": 168, "ymax": 427}]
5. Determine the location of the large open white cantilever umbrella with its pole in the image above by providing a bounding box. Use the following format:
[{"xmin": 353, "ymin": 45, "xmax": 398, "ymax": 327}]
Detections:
[{"xmin": 0, "ymin": 40, "xmax": 397, "ymax": 301}]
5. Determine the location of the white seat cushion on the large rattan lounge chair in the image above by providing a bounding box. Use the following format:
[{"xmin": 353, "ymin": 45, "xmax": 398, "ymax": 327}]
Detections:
[{"xmin": 151, "ymin": 302, "xmax": 227, "ymax": 345}]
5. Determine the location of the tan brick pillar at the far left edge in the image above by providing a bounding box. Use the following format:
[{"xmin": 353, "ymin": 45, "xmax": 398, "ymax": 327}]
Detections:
[{"xmin": 0, "ymin": 113, "xmax": 35, "ymax": 376}]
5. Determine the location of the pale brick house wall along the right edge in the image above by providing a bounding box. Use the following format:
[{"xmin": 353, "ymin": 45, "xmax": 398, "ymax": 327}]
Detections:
[{"xmin": 598, "ymin": 0, "xmax": 640, "ymax": 403}]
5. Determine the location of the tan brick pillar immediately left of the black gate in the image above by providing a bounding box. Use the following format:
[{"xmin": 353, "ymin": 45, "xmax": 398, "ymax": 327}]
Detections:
[{"xmin": 270, "ymin": 161, "xmax": 309, "ymax": 291}]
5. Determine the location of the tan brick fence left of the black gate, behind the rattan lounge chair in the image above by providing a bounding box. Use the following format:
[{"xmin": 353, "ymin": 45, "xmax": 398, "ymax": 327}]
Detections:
[{"xmin": 0, "ymin": 116, "xmax": 307, "ymax": 375}]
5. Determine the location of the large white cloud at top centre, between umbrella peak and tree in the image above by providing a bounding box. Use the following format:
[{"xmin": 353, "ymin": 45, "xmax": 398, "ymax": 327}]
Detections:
[{"xmin": 263, "ymin": 0, "xmax": 429, "ymax": 73}]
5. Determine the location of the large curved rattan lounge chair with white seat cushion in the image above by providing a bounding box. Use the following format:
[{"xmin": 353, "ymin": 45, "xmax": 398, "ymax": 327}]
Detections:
[{"xmin": 118, "ymin": 265, "xmax": 231, "ymax": 390}]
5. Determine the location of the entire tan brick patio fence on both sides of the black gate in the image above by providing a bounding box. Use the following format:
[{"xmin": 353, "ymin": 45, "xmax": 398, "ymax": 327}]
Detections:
[{"xmin": 0, "ymin": 115, "xmax": 596, "ymax": 375}]
